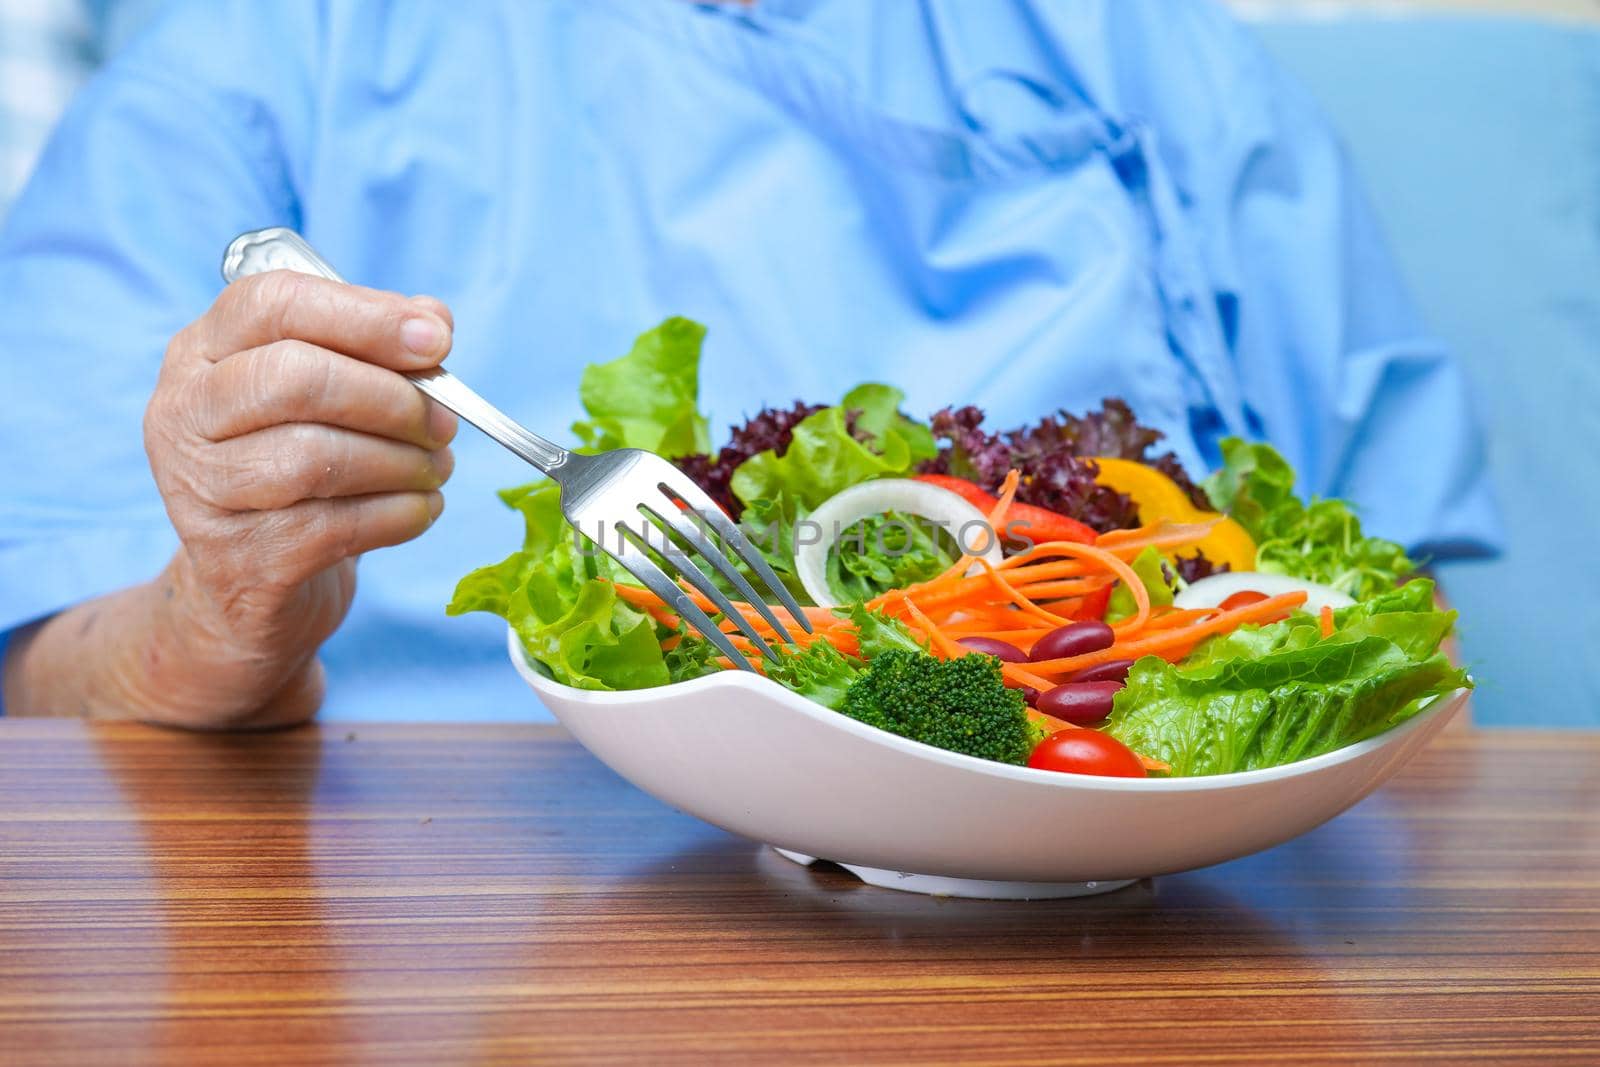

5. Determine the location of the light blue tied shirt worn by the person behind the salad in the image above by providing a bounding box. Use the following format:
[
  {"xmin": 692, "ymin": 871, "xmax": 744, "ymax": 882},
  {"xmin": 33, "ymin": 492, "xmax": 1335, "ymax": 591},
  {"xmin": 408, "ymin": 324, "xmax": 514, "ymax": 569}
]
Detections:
[{"xmin": 0, "ymin": 0, "xmax": 1498, "ymax": 718}]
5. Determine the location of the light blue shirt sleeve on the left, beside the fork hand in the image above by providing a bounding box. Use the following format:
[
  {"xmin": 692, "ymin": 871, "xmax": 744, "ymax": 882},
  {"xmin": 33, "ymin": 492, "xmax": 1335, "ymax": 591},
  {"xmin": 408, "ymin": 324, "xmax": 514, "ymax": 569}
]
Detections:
[{"xmin": 0, "ymin": 21, "xmax": 296, "ymax": 652}]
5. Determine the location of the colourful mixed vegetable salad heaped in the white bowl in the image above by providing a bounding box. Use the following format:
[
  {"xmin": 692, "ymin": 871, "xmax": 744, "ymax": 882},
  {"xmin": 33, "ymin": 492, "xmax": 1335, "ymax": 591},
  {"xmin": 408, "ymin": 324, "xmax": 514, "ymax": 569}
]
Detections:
[{"xmin": 448, "ymin": 318, "xmax": 1470, "ymax": 776}]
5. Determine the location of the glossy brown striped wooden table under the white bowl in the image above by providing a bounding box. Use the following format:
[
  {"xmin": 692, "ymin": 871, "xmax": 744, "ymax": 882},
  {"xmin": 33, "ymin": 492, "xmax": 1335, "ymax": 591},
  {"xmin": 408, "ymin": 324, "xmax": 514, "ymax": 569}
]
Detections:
[{"xmin": 0, "ymin": 721, "xmax": 1600, "ymax": 1067}]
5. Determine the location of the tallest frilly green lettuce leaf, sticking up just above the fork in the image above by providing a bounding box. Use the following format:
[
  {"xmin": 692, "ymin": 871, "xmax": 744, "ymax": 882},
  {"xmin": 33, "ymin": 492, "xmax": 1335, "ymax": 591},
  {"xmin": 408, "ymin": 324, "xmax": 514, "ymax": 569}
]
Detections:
[{"xmin": 573, "ymin": 318, "xmax": 710, "ymax": 459}]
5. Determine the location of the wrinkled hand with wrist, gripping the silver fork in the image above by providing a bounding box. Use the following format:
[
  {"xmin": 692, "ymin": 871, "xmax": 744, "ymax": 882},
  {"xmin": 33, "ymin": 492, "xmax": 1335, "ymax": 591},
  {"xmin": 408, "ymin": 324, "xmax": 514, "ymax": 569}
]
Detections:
[{"xmin": 144, "ymin": 270, "xmax": 456, "ymax": 726}]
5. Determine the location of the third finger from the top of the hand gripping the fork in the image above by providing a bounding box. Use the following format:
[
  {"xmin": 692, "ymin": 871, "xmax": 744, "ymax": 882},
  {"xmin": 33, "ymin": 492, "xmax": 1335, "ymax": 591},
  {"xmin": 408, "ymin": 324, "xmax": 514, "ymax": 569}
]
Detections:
[{"xmin": 197, "ymin": 422, "xmax": 454, "ymax": 512}]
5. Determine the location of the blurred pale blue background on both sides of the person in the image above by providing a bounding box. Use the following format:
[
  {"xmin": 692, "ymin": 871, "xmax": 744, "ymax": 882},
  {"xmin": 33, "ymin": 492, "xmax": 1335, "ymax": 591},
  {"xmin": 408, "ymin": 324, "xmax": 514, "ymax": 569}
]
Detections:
[{"xmin": 0, "ymin": 0, "xmax": 1600, "ymax": 726}]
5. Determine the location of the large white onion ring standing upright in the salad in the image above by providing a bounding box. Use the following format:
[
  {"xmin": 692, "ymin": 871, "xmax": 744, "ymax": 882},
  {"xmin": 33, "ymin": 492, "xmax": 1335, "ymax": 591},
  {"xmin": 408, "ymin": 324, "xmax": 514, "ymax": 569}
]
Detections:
[{"xmin": 795, "ymin": 478, "xmax": 1005, "ymax": 608}]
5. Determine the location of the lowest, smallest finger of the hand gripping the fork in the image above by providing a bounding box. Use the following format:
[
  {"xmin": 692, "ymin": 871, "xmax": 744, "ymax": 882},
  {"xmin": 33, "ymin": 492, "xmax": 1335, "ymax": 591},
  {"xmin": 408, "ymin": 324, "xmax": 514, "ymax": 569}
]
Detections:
[{"xmin": 246, "ymin": 493, "xmax": 445, "ymax": 585}]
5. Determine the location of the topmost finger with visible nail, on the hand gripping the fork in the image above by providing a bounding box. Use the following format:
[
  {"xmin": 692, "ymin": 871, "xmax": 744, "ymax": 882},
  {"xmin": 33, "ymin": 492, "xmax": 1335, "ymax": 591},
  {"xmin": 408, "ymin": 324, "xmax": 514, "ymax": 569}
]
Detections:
[{"xmin": 195, "ymin": 270, "xmax": 451, "ymax": 371}]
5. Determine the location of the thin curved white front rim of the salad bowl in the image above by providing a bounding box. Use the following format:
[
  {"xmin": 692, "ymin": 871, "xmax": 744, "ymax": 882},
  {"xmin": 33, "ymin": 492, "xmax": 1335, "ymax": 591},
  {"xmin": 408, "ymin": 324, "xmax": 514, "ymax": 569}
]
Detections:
[{"xmin": 506, "ymin": 625, "xmax": 1469, "ymax": 793}]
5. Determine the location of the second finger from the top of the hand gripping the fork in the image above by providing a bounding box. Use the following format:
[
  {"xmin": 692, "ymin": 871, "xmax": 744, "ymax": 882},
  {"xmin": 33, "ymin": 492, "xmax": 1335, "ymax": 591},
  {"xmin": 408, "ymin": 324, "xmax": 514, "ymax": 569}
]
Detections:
[{"xmin": 192, "ymin": 341, "xmax": 456, "ymax": 450}]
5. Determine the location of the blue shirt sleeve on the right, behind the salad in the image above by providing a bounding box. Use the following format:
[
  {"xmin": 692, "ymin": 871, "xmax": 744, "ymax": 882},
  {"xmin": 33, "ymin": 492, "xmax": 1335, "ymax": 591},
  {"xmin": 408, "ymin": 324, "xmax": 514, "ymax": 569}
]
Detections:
[{"xmin": 1109, "ymin": 0, "xmax": 1502, "ymax": 560}]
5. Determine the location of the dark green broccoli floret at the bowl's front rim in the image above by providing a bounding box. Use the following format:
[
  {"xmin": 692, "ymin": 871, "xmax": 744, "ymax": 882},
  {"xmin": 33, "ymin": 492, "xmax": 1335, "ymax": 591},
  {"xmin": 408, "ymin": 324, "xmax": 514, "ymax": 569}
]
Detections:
[{"xmin": 838, "ymin": 648, "xmax": 1038, "ymax": 765}]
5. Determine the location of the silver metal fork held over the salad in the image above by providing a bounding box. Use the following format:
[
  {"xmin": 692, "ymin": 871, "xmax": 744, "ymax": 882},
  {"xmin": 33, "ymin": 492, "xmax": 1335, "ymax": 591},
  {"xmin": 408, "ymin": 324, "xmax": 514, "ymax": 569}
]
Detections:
[{"xmin": 222, "ymin": 227, "xmax": 811, "ymax": 670}]
